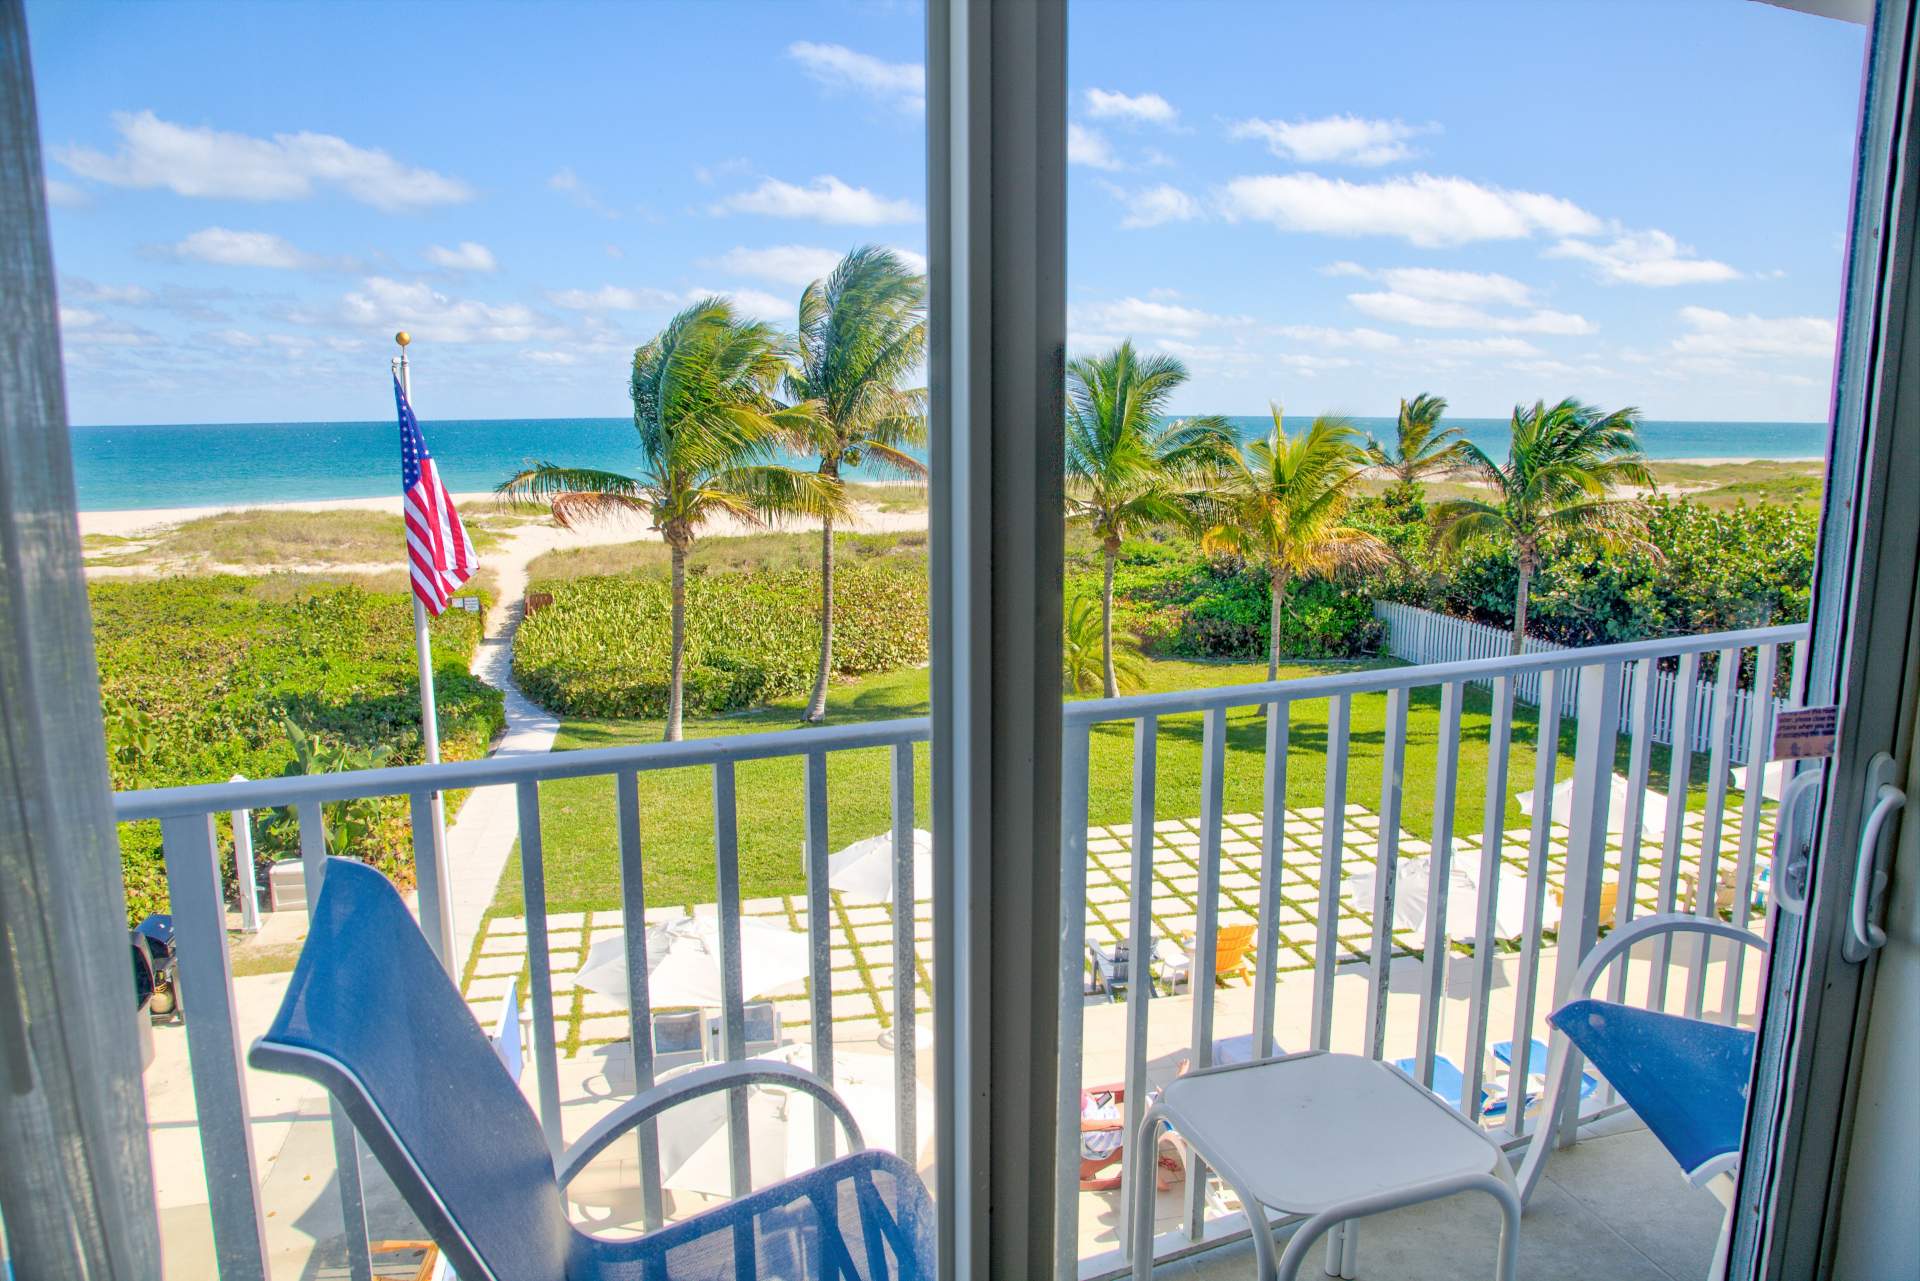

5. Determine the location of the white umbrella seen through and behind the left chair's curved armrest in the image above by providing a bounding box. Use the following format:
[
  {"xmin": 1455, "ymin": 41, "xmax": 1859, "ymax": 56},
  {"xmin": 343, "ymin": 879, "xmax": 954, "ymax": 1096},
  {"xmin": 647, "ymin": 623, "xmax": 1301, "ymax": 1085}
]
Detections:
[{"xmin": 659, "ymin": 1045, "xmax": 933, "ymax": 1196}]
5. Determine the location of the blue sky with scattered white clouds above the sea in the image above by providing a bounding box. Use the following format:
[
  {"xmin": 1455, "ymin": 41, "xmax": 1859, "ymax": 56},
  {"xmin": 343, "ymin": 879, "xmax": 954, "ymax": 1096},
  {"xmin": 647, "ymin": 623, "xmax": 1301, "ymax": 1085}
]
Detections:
[{"xmin": 29, "ymin": 0, "xmax": 1864, "ymax": 423}]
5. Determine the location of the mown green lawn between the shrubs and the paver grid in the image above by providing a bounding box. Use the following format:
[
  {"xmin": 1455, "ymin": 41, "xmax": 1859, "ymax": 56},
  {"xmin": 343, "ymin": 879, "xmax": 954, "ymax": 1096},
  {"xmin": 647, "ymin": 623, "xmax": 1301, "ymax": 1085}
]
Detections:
[{"xmin": 492, "ymin": 661, "xmax": 1728, "ymax": 914}]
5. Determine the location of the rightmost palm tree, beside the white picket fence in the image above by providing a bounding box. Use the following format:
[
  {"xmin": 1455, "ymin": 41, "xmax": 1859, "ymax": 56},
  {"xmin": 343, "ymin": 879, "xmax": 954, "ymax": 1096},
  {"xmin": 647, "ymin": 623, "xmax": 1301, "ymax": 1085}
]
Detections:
[{"xmin": 1434, "ymin": 398, "xmax": 1653, "ymax": 653}]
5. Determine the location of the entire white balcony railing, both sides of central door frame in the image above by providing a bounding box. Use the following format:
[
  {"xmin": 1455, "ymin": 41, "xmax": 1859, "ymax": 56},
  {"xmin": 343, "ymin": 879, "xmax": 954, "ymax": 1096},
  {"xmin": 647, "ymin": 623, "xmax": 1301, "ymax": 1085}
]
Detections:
[{"xmin": 115, "ymin": 628, "xmax": 1805, "ymax": 1281}]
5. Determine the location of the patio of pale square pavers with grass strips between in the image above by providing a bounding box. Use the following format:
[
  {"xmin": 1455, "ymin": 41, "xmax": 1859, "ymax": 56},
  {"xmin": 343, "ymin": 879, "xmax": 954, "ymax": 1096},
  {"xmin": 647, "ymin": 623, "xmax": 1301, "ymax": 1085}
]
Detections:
[{"xmin": 463, "ymin": 805, "xmax": 1772, "ymax": 1056}]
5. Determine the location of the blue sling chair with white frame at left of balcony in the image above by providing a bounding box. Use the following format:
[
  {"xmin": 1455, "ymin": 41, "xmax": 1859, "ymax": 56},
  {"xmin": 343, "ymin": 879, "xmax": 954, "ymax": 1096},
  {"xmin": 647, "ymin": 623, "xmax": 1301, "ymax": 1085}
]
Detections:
[{"xmin": 248, "ymin": 858, "xmax": 935, "ymax": 1281}]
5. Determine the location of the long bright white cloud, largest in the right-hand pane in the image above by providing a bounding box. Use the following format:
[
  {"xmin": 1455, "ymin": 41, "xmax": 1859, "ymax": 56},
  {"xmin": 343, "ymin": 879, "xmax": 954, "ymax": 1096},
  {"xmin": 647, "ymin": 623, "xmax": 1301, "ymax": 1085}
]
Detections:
[{"xmin": 1219, "ymin": 173, "xmax": 1601, "ymax": 248}]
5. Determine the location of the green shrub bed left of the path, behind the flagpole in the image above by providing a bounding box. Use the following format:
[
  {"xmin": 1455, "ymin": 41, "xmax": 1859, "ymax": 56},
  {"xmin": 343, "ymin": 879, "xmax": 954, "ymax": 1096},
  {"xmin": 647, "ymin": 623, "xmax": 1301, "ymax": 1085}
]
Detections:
[{"xmin": 88, "ymin": 576, "xmax": 505, "ymax": 920}]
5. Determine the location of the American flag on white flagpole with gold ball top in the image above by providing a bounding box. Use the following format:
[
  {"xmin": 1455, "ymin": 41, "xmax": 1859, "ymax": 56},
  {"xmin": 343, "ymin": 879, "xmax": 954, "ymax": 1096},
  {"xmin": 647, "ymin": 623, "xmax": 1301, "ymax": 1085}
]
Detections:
[{"xmin": 392, "ymin": 330, "xmax": 476, "ymax": 972}]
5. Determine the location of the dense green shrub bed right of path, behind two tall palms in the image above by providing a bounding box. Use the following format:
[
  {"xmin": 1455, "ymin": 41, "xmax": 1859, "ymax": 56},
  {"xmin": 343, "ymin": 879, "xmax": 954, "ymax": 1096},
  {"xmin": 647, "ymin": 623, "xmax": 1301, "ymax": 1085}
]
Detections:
[{"xmin": 513, "ymin": 559, "xmax": 927, "ymax": 716}]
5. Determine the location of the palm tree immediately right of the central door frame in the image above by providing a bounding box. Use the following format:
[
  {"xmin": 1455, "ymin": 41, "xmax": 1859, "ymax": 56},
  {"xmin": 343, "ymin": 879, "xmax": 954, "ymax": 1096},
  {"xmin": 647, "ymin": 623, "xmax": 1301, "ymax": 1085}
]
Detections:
[{"xmin": 1068, "ymin": 342, "xmax": 1233, "ymax": 697}]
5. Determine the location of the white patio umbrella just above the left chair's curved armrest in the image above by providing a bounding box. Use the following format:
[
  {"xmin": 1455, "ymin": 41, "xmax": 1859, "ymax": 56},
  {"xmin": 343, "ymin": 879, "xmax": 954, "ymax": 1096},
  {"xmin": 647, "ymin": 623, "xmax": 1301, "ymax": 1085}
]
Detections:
[{"xmin": 574, "ymin": 916, "xmax": 808, "ymax": 1008}]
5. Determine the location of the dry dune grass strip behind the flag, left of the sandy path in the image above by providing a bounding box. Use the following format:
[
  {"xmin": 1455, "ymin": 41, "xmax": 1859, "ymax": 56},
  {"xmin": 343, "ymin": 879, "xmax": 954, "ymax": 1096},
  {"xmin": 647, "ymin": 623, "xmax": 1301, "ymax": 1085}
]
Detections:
[{"xmin": 86, "ymin": 509, "xmax": 499, "ymax": 568}]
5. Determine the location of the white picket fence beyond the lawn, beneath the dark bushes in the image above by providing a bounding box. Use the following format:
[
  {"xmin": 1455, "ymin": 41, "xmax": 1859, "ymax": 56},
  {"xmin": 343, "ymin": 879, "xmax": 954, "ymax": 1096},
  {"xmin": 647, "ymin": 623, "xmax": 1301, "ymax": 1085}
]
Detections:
[{"xmin": 1373, "ymin": 601, "xmax": 1799, "ymax": 764}]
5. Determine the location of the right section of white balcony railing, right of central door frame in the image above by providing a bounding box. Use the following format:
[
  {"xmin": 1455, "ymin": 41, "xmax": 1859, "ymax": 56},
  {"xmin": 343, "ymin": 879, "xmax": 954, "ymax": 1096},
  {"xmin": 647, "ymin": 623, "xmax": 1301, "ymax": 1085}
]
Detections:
[{"xmin": 1056, "ymin": 626, "xmax": 1807, "ymax": 1277}]
